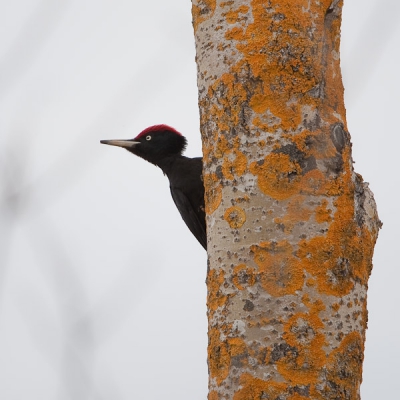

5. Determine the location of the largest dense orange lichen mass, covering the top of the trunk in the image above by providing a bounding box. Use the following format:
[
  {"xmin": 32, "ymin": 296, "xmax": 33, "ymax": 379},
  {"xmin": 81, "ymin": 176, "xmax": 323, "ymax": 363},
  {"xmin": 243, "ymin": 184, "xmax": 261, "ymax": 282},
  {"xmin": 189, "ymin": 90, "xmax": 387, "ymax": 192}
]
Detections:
[{"xmin": 222, "ymin": 0, "xmax": 338, "ymax": 131}]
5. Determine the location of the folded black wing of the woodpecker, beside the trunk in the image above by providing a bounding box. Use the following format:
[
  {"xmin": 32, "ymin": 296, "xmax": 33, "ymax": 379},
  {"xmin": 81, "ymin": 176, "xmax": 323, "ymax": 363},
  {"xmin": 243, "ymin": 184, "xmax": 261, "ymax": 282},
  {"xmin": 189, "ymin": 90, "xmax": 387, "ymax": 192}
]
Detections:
[{"xmin": 170, "ymin": 187, "xmax": 207, "ymax": 250}]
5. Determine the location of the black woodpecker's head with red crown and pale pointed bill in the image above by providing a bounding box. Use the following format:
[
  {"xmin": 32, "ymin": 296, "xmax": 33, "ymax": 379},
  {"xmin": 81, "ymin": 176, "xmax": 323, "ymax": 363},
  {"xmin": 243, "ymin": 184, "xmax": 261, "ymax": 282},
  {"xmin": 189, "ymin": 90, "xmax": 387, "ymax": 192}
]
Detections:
[{"xmin": 100, "ymin": 125, "xmax": 187, "ymax": 165}]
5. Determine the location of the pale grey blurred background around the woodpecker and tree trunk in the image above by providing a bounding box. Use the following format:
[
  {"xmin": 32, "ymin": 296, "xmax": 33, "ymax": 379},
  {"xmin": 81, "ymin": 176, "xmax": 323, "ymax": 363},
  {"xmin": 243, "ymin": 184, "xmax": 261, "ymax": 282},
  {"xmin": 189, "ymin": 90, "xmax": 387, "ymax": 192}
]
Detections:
[{"xmin": 0, "ymin": 0, "xmax": 400, "ymax": 400}]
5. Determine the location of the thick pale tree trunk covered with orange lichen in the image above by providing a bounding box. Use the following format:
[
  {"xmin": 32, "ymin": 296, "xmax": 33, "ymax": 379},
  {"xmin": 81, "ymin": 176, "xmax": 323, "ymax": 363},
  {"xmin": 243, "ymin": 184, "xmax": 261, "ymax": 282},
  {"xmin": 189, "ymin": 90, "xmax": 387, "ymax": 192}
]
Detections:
[{"xmin": 192, "ymin": 0, "xmax": 380, "ymax": 400}]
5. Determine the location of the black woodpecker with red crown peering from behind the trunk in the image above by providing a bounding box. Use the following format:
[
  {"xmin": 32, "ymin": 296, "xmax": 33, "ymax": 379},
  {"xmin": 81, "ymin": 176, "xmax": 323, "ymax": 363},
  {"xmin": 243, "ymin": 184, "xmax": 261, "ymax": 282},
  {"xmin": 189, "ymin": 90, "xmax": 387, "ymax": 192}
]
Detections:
[{"xmin": 100, "ymin": 124, "xmax": 207, "ymax": 250}]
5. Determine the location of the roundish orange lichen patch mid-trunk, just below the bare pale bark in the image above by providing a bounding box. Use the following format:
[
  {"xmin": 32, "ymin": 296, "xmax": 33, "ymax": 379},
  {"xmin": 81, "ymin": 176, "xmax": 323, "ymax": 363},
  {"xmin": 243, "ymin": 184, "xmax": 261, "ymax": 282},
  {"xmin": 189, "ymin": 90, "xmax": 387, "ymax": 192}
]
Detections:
[{"xmin": 250, "ymin": 240, "xmax": 304, "ymax": 296}]
